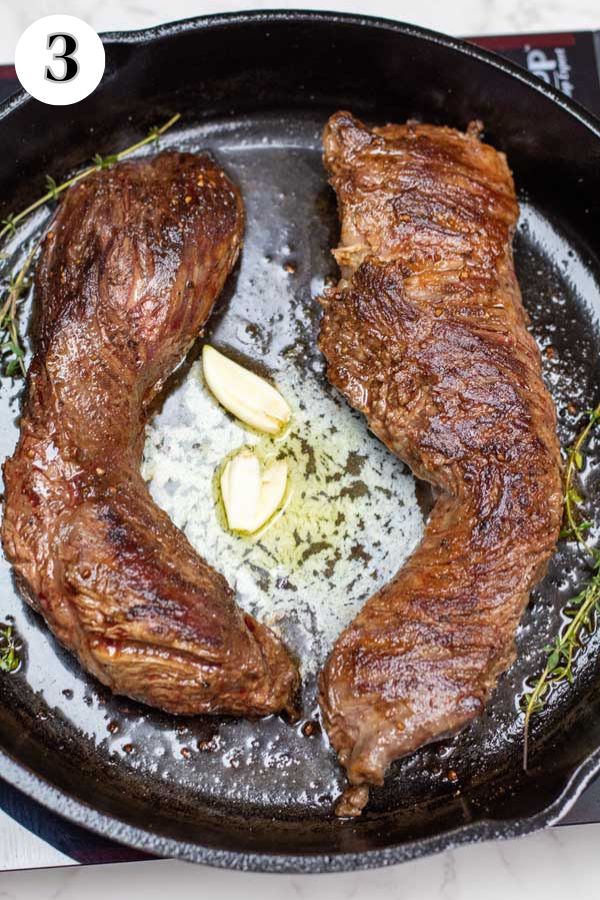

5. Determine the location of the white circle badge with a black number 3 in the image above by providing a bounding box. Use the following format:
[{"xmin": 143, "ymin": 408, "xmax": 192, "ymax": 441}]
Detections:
[{"xmin": 15, "ymin": 16, "xmax": 104, "ymax": 106}]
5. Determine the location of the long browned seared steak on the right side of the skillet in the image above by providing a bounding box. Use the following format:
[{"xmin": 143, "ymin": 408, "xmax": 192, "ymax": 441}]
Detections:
[{"xmin": 320, "ymin": 112, "xmax": 562, "ymax": 815}]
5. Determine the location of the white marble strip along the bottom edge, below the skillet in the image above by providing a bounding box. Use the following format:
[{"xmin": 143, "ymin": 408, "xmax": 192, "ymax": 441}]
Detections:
[{"xmin": 0, "ymin": 825, "xmax": 600, "ymax": 900}]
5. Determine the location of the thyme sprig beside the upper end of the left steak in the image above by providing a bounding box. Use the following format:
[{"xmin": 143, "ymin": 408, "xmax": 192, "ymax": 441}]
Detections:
[{"xmin": 0, "ymin": 113, "xmax": 180, "ymax": 376}]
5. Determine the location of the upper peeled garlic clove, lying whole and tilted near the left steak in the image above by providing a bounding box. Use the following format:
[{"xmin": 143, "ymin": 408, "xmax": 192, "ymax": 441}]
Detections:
[{"xmin": 202, "ymin": 344, "xmax": 291, "ymax": 434}]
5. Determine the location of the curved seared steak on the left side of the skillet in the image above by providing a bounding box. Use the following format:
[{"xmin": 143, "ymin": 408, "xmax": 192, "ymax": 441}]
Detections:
[{"xmin": 2, "ymin": 153, "xmax": 298, "ymax": 715}]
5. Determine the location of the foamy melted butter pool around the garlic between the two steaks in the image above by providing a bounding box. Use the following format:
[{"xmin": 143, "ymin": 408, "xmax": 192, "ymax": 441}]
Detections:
[{"xmin": 142, "ymin": 363, "xmax": 422, "ymax": 674}]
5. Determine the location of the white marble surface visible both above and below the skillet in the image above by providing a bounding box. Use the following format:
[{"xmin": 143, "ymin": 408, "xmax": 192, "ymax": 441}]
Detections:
[{"xmin": 0, "ymin": 0, "xmax": 600, "ymax": 900}]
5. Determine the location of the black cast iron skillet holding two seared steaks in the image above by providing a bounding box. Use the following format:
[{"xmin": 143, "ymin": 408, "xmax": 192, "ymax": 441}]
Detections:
[{"xmin": 0, "ymin": 12, "xmax": 600, "ymax": 872}]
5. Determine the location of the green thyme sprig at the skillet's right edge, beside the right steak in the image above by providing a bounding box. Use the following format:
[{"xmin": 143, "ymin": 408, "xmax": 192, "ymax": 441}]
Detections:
[{"xmin": 521, "ymin": 404, "xmax": 600, "ymax": 769}]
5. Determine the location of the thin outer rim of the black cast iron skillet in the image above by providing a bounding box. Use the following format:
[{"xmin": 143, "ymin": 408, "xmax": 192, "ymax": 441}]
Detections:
[{"xmin": 0, "ymin": 9, "xmax": 600, "ymax": 874}]
